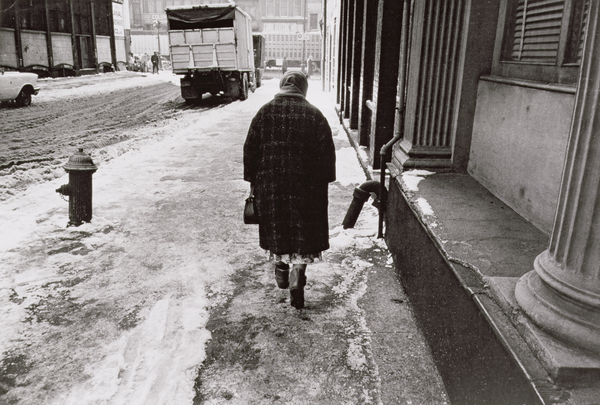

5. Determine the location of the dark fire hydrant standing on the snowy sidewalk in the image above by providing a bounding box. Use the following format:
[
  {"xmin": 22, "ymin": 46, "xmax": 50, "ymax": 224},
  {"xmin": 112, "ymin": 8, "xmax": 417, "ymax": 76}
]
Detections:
[{"xmin": 56, "ymin": 148, "xmax": 98, "ymax": 227}]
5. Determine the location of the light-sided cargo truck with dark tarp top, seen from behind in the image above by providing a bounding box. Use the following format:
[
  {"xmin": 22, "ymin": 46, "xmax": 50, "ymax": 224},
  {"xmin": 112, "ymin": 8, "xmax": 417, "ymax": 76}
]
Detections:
[{"xmin": 165, "ymin": 3, "xmax": 256, "ymax": 103}]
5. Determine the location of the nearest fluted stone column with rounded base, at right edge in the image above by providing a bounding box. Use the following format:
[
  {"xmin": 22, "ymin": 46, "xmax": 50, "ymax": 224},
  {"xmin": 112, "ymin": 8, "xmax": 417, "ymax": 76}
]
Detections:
[{"xmin": 515, "ymin": 1, "xmax": 600, "ymax": 356}]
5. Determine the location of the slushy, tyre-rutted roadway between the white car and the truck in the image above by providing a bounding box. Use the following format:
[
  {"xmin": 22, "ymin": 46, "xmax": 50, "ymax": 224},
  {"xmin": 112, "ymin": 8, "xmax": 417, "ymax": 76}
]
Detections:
[{"xmin": 0, "ymin": 74, "xmax": 184, "ymax": 200}]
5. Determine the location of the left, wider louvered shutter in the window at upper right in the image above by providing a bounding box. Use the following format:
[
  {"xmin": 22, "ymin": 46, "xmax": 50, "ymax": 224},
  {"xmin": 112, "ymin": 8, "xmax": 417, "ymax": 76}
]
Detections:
[{"xmin": 511, "ymin": 0, "xmax": 564, "ymax": 64}]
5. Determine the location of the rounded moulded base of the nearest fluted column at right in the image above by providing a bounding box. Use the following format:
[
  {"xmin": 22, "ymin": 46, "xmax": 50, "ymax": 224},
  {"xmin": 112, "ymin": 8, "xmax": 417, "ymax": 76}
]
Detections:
[{"xmin": 515, "ymin": 251, "xmax": 600, "ymax": 359}]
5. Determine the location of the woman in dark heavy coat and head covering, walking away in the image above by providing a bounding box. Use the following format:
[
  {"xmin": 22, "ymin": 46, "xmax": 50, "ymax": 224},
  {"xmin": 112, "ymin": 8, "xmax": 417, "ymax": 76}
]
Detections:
[{"xmin": 244, "ymin": 71, "xmax": 335, "ymax": 309}]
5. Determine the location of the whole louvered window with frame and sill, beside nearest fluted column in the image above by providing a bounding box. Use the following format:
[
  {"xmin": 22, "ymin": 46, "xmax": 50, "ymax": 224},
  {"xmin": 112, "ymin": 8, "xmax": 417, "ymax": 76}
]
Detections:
[{"xmin": 494, "ymin": 0, "xmax": 589, "ymax": 84}]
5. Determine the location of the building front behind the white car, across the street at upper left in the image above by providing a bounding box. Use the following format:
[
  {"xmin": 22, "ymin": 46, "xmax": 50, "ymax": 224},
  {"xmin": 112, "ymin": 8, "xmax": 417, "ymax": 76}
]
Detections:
[{"xmin": 0, "ymin": 0, "xmax": 127, "ymax": 76}]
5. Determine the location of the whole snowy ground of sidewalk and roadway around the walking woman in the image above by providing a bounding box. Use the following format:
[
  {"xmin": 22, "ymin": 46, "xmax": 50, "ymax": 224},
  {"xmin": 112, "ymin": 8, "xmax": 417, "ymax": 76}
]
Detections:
[{"xmin": 0, "ymin": 72, "xmax": 449, "ymax": 405}]
